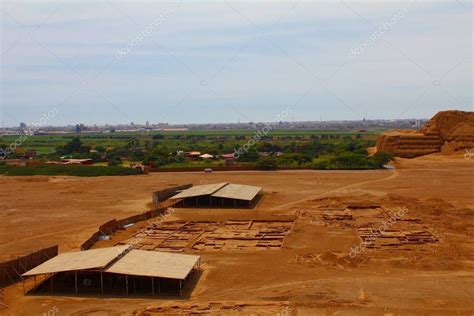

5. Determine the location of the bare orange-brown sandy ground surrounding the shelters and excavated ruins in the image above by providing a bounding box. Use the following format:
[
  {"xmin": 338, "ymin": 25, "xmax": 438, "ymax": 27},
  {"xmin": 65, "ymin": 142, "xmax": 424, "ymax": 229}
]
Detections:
[{"xmin": 0, "ymin": 155, "xmax": 474, "ymax": 315}]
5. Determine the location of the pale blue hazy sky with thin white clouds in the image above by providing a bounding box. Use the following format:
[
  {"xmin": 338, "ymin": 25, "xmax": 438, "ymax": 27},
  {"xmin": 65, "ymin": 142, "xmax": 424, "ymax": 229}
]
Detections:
[{"xmin": 0, "ymin": 0, "xmax": 473, "ymax": 126}]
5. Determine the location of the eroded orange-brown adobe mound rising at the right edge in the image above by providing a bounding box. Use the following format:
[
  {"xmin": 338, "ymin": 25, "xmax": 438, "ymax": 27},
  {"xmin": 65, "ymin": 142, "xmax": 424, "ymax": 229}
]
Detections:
[{"xmin": 377, "ymin": 111, "xmax": 474, "ymax": 158}]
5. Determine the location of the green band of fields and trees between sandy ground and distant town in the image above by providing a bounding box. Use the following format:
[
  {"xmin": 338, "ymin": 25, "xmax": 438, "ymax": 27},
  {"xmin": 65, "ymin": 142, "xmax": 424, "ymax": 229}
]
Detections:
[{"xmin": 0, "ymin": 130, "xmax": 389, "ymax": 174}]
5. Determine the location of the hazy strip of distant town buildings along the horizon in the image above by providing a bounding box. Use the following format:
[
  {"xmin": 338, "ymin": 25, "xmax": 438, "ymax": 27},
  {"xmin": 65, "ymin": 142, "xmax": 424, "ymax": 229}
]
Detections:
[{"xmin": 0, "ymin": 119, "xmax": 427, "ymax": 135}]
